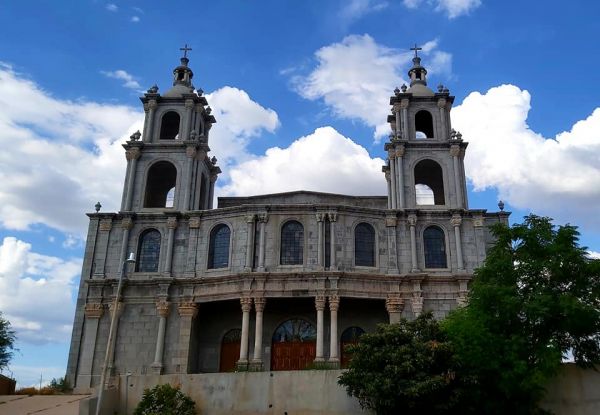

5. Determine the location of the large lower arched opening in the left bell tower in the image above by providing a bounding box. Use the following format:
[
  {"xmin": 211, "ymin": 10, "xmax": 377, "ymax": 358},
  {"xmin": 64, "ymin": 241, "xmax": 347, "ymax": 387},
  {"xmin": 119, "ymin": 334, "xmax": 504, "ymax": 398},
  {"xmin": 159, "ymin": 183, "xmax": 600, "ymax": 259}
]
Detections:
[{"xmin": 144, "ymin": 161, "xmax": 177, "ymax": 208}]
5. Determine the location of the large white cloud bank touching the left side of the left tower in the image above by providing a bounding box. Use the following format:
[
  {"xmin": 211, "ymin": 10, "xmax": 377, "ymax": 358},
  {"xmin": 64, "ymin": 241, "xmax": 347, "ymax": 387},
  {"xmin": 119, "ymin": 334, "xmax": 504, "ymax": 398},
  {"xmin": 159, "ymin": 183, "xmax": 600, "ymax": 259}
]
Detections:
[{"xmin": 0, "ymin": 64, "xmax": 143, "ymax": 236}]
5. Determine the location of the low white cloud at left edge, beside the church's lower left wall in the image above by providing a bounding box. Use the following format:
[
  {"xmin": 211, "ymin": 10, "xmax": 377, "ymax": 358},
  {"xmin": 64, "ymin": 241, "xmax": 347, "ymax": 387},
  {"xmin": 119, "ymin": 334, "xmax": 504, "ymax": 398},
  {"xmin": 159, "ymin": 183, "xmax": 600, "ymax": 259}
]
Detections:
[{"xmin": 0, "ymin": 237, "xmax": 81, "ymax": 344}]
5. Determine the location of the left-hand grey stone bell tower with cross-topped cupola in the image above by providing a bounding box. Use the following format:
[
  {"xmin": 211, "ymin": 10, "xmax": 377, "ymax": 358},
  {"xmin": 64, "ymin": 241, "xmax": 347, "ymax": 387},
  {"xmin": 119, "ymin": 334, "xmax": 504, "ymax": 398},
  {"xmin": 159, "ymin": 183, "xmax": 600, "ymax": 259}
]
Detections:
[{"xmin": 121, "ymin": 45, "xmax": 221, "ymax": 212}]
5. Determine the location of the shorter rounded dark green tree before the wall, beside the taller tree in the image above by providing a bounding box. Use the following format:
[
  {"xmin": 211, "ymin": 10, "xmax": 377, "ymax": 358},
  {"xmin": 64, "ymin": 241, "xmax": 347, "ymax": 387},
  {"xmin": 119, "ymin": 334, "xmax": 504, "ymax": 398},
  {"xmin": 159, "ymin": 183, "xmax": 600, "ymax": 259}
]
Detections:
[{"xmin": 339, "ymin": 313, "xmax": 462, "ymax": 415}]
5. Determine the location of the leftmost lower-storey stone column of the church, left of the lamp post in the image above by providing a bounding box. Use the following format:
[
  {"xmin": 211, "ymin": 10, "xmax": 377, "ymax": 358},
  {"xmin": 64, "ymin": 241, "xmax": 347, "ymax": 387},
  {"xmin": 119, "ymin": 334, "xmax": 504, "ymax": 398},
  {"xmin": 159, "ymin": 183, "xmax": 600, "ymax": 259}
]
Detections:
[{"xmin": 74, "ymin": 303, "xmax": 104, "ymax": 389}]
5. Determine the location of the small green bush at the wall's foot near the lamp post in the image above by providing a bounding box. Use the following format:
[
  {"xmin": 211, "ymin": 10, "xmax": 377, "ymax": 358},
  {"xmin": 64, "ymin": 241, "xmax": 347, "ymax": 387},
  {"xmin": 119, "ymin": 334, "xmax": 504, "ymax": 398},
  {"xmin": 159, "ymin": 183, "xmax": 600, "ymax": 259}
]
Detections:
[{"xmin": 134, "ymin": 384, "xmax": 196, "ymax": 415}]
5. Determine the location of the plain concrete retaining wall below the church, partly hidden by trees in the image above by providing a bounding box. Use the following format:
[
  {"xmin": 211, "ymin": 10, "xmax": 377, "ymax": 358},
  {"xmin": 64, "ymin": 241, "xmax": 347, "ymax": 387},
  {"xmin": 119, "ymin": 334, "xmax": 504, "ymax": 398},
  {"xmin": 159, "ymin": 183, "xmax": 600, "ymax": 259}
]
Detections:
[{"xmin": 101, "ymin": 365, "xmax": 600, "ymax": 415}]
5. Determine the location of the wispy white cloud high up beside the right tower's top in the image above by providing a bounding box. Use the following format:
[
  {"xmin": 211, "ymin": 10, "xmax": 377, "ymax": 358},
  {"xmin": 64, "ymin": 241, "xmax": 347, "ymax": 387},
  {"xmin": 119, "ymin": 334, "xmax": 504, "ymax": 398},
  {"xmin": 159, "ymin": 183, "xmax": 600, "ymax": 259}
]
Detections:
[{"xmin": 293, "ymin": 35, "xmax": 452, "ymax": 141}]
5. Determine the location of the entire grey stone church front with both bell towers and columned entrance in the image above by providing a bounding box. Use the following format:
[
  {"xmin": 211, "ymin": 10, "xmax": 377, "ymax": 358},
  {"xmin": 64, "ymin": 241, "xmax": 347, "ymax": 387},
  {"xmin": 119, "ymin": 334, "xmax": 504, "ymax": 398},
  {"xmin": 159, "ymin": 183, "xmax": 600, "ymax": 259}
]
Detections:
[{"xmin": 67, "ymin": 53, "xmax": 508, "ymax": 391}]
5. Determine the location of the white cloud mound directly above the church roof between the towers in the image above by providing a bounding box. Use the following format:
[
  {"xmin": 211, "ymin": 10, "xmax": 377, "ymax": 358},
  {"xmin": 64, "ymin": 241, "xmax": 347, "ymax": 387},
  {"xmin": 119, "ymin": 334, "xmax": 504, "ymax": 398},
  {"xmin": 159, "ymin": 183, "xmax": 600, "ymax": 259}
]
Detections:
[{"xmin": 220, "ymin": 127, "xmax": 386, "ymax": 196}]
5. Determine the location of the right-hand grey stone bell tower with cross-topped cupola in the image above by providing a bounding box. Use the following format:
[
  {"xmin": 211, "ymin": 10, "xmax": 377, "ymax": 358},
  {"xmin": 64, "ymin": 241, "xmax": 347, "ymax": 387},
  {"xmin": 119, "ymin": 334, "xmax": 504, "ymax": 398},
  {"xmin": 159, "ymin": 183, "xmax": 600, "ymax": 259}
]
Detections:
[{"xmin": 382, "ymin": 45, "xmax": 468, "ymax": 210}]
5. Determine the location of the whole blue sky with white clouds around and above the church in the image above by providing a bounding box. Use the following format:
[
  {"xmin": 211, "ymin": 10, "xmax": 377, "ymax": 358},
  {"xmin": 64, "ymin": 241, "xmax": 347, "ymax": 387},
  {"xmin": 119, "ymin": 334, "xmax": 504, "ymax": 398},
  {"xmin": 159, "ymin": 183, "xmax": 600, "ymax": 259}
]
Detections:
[{"xmin": 0, "ymin": 0, "xmax": 600, "ymax": 386}]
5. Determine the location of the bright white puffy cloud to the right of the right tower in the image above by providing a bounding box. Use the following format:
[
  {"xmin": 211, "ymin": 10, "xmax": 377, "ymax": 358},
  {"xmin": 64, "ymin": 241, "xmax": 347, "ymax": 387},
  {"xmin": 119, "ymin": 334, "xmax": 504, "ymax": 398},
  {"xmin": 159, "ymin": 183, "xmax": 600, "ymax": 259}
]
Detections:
[{"xmin": 452, "ymin": 85, "xmax": 600, "ymax": 229}]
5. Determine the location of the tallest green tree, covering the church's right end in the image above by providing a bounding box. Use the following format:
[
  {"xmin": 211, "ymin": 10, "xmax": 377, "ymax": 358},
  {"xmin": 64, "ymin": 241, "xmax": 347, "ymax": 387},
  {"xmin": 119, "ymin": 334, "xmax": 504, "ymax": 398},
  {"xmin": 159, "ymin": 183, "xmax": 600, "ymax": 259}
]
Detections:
[{"xmin": 444, "ymin": 215, "xmax": 600, "ymax": 415}]
